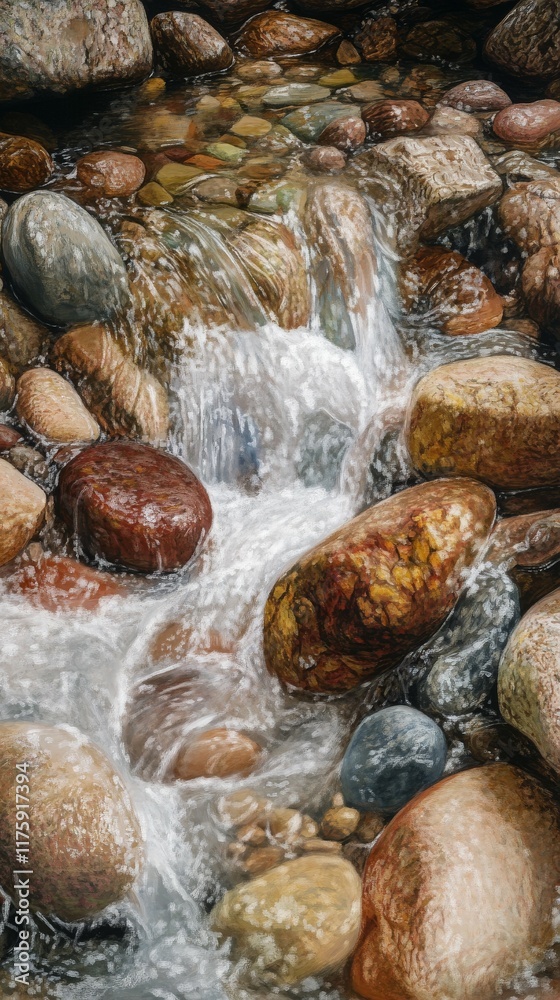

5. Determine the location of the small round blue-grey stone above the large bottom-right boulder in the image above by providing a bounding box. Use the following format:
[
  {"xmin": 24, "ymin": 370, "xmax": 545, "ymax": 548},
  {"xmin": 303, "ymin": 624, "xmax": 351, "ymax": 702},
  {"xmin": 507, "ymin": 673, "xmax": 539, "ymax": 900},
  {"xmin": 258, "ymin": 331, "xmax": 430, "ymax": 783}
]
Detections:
[{"xmin": 340, "ymin": 705, "xmax": 447, "ymax": 815}]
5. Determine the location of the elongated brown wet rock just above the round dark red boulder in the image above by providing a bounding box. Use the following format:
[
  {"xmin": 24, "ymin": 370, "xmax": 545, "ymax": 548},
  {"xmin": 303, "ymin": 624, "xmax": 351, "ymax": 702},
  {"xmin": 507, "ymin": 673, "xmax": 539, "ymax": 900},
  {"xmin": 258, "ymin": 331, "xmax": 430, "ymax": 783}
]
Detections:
[{"xmin": 53, "ymin": 326, "xmax": 169, "ymax": 444}]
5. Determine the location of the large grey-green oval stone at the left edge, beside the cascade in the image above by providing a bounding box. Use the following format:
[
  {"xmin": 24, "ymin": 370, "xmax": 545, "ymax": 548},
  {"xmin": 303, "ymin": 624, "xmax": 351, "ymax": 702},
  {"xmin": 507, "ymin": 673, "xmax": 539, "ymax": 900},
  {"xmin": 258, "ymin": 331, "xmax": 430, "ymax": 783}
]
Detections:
[{"xmin": 2, "ymin": 191, "xmax": 128, "ymax": 326}]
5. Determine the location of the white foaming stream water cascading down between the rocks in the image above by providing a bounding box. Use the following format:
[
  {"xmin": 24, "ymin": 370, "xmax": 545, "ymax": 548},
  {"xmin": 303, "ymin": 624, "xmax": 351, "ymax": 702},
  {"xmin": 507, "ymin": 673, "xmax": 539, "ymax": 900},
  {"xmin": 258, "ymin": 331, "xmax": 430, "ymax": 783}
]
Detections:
[{"xmin": 0, "ymin": 60, "xmax": 560, "ymax": 1000}]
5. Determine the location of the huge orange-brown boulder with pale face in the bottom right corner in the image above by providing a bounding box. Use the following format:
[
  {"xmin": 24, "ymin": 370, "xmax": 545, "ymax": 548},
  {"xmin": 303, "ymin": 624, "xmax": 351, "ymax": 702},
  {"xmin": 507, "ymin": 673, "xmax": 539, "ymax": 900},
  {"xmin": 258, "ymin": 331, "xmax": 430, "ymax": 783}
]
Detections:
[{"xmin": 352, "ymin": 764, "xmax": 560, "ymax": 1000}]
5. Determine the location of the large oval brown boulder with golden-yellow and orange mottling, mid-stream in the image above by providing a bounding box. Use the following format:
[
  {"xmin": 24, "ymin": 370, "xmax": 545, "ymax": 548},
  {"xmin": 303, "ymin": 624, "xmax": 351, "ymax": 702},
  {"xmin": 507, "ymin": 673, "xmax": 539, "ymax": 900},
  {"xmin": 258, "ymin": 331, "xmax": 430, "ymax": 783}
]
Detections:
[{"xmin": 264, "ymin": 479, "xmax": 496, "ymax": 693}]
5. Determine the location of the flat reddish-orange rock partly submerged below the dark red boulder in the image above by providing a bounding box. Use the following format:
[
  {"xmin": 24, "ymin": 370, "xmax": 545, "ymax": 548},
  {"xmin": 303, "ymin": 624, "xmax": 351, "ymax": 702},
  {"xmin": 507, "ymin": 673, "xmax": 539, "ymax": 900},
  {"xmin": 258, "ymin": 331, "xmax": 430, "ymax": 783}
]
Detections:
[{"xmin": 6, "ymin": 546, "xmax": 126, "ymax": 611}]
